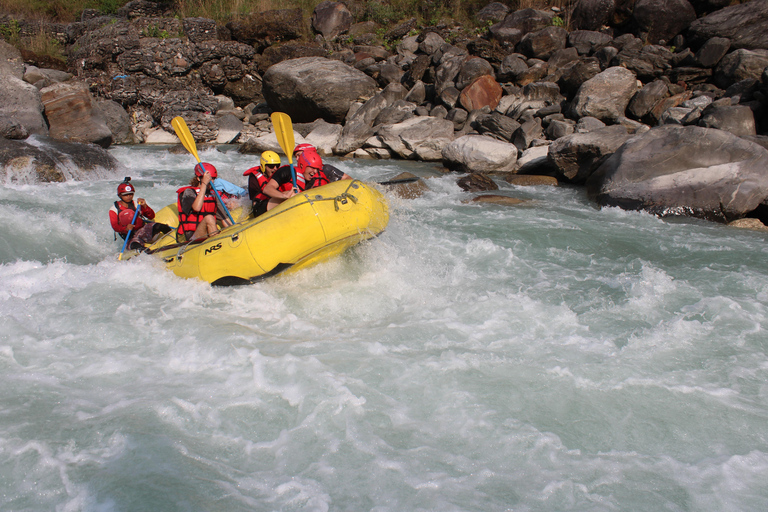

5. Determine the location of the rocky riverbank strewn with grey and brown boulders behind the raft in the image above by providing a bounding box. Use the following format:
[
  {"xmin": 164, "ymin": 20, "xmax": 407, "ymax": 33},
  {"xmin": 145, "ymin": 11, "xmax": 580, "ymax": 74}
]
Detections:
[{"xmin": 0, "ymin": 0, "xmax": 768, "ymax": 228}]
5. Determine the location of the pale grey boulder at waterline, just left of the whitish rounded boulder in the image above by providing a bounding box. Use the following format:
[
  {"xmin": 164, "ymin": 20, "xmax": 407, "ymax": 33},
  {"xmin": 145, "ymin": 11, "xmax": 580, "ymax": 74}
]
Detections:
[{"xmin": 376, "ymin": 117, "xmax": 453, "ymax": 161}]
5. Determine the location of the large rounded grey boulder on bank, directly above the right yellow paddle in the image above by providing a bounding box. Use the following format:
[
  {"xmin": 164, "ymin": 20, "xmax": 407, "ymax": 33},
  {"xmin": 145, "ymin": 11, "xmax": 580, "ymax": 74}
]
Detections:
[{"xmin": 262, "ymin": 57, "xmax": 376, "ymax": 123}]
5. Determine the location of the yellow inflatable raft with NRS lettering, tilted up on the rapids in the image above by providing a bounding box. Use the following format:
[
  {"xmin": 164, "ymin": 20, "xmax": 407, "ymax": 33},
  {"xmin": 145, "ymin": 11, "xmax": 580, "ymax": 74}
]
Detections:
[{"xmin": 139, "ymin": 180, "xmax": 389, "ymax": 286}]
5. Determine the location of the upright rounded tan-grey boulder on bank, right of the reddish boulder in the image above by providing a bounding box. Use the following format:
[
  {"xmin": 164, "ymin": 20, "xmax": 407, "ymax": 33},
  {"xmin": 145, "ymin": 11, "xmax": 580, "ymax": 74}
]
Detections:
[{"xmin": 570, "ymin": 67, "xmax": 637, "ymax": 121}]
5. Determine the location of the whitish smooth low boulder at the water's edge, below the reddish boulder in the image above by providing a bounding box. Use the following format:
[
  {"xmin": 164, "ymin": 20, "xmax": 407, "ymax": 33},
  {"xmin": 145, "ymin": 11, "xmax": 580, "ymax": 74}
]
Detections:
[{"xmin": 442, "ymin": 135, "xmax": 517, "ymax": 172}]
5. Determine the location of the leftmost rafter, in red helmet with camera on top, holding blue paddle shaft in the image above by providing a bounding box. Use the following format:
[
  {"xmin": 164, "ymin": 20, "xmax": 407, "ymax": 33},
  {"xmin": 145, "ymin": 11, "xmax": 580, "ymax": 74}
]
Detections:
[{"xmin": 109, "ymin": 178, "xmax": 173, "ymax": 249}]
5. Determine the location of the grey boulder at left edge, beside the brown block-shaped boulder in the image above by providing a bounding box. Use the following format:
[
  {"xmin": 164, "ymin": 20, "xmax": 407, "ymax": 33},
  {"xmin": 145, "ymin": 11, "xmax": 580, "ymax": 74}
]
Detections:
[{"xmin": 0, "ymin": 74, "xmax": 48, "ymax": 135}]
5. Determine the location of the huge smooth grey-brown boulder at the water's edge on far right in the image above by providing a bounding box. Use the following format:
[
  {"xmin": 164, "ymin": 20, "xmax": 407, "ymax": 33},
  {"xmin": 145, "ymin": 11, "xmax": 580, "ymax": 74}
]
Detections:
[{"xmin": 587, "ymin": 125, "xmax": 768, "ymax": 221}]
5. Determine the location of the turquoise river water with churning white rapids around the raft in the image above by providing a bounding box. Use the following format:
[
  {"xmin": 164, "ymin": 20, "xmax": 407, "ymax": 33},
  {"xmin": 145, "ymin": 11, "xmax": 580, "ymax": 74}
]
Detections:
[{"xmin": 0, "ymin": 148, "xmax": 768, "ymax": 512}]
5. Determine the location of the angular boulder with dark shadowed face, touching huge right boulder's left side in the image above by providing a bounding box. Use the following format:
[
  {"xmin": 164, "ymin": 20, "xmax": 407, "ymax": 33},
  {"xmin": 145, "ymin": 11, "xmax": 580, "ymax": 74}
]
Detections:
[{"xmin": 548, "ymin": 125, "xmax": 631, "ymax": 184}]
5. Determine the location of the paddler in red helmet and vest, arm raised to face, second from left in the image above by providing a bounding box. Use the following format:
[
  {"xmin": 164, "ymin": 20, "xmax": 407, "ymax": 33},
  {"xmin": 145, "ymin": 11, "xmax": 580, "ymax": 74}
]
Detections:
[{"xmin": 176, "ymin": 163, "xmax": 232, "ymax": 242}]
